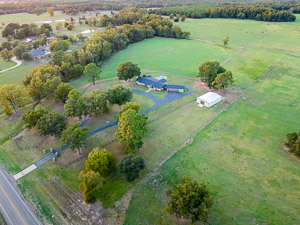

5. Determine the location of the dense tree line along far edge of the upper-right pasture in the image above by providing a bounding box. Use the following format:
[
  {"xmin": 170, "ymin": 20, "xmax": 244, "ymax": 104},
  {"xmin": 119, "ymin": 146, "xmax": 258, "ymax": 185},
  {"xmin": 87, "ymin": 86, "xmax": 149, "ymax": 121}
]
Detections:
[{"xmin": 149, "ymin": 5, "xmax": 296, "ymax": 22}]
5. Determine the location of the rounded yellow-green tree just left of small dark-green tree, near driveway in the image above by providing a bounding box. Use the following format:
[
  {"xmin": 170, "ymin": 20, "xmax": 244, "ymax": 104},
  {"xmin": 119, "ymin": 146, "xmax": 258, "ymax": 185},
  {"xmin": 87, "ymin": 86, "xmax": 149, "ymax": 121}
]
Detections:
[{"xmin": 84, "ymin": 148, "xmax": 116, "ymax": 175}]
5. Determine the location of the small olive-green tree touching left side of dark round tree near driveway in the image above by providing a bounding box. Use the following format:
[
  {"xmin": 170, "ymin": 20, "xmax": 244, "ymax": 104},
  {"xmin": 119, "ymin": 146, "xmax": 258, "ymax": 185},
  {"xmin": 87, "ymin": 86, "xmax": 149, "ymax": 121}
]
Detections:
[{"xmin": 22, "ymin": 106, "xmax": 49, "ymax": 130}]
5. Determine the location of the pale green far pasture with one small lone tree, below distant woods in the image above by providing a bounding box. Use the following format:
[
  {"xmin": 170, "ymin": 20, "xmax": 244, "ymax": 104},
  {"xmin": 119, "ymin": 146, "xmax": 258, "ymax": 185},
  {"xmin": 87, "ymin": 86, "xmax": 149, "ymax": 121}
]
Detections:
[{"xmin": 178, "ymin": 15, "xmax": 300, "ymax": 52}]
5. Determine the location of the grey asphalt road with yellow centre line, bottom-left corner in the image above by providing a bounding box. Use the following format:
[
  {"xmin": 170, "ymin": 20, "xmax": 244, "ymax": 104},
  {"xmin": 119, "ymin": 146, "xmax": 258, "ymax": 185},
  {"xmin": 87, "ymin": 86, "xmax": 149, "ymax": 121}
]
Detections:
[{"xmin": 0, "ymin": 169, "xmax": 41, "ymax": 225}]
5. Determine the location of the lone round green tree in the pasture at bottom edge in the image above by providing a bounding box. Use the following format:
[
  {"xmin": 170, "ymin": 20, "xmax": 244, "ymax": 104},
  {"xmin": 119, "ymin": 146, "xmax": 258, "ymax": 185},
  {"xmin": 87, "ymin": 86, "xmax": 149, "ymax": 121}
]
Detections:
[{"xmin": 164, "ymin": 176, "xmax": 213, "ymax": 223}]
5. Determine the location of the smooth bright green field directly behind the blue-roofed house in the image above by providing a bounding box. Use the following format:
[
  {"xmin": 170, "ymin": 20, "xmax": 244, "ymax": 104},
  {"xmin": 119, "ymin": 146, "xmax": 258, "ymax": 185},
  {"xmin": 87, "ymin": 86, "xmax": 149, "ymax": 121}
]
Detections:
[{"xmin": 72, "ymin": 38, "xmax": 238, "ymax": 88}]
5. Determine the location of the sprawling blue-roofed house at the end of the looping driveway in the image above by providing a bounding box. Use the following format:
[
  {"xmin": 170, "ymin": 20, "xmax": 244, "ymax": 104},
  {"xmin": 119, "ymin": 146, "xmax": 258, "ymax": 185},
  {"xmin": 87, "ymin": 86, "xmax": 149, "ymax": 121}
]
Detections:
[{"xmin": 136, "ymin": 75, "xmax": 185, "ymax": 92}]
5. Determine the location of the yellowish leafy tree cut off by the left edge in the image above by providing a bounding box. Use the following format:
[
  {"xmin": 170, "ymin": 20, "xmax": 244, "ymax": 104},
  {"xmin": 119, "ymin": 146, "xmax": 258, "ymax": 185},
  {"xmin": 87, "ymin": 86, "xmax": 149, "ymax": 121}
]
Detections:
[{"xmin": 0, "ymin": 84, "xmax": 27, "ymax": 116}]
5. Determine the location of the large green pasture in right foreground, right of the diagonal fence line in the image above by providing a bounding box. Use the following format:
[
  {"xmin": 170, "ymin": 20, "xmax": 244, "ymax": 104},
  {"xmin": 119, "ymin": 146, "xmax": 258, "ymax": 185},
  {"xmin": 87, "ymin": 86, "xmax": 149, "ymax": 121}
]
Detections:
[{"xmin": 125, "ymin": 57, "xmax": 300, "ymax": 224}]
